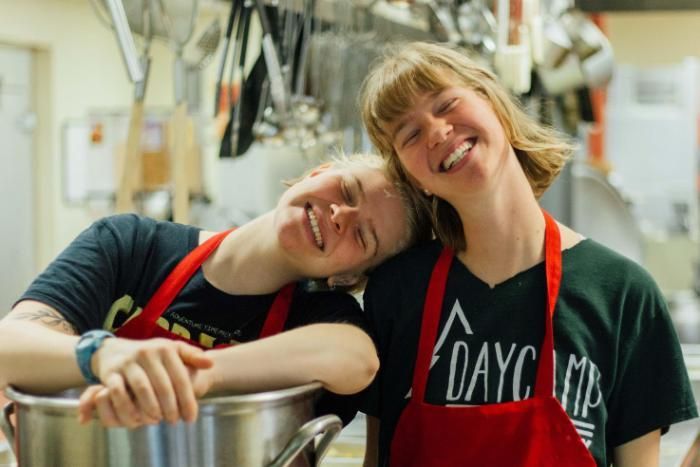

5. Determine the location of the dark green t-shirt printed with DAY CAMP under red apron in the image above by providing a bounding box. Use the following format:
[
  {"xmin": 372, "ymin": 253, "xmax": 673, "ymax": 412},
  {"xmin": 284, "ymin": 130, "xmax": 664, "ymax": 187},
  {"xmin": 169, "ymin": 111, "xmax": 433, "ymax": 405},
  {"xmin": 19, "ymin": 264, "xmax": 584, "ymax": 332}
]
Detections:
[{"xmin": 363, "ymin": 240, "xmax": 697, "ymax": 466}]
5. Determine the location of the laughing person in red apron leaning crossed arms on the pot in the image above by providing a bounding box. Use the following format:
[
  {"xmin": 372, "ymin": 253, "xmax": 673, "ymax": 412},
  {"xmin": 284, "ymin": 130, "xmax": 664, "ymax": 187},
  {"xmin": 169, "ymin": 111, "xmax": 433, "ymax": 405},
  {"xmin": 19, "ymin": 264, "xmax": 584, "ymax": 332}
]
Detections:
[{"xmin": 0, "ymin": 156, "xmax": 428, "ymax": 427}]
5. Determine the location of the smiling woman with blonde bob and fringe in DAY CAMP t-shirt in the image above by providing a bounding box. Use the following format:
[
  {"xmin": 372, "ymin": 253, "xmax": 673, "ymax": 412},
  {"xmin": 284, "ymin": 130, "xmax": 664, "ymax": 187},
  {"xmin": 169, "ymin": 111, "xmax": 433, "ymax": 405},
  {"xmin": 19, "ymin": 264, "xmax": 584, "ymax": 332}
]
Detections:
[{"xmin": 362, "ymin": 43, "xmax": 697, "ymax": 467}]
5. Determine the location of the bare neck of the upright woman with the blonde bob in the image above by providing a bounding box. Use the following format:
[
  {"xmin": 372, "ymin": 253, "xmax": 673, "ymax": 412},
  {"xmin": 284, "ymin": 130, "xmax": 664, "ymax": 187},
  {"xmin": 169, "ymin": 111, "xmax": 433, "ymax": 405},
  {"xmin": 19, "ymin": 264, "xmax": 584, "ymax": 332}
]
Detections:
[{"xmin": 455, "ymin": 165, "xmax": 545, "ymax": 287}]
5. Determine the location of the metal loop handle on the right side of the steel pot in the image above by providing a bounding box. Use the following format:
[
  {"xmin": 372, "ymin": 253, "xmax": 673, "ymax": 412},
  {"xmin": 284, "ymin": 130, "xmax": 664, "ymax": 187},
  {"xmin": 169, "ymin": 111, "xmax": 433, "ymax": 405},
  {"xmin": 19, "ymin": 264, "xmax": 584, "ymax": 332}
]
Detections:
[{"xmin": 268, "ymin": 415, "xmax": 343, "ymax": 467}]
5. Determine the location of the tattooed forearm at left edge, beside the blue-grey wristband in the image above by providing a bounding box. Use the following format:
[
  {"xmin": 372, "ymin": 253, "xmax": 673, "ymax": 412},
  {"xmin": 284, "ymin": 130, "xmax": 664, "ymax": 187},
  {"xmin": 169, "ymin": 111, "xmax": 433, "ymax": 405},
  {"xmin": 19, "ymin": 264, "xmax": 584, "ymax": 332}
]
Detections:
[{"xmin": 0, "ymin": 302, "xmax": 84, "ymax": 393}]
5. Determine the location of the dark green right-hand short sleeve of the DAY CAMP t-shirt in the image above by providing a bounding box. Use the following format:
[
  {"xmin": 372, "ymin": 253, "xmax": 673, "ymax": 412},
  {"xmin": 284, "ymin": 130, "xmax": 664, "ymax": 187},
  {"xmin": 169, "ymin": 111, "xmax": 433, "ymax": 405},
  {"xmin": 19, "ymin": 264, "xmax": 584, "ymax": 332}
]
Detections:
[{"xmin": 607, "ymin": 277, "xmax": 698, "ymax": 447}]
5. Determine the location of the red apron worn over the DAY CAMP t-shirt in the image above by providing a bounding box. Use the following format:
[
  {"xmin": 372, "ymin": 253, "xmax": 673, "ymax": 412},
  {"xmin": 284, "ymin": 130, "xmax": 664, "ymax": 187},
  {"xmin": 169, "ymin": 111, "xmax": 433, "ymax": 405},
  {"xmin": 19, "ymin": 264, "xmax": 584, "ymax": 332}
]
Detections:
[{"xmin": 390, "ymin": 213, "xmax": 596, "ymax": 467}]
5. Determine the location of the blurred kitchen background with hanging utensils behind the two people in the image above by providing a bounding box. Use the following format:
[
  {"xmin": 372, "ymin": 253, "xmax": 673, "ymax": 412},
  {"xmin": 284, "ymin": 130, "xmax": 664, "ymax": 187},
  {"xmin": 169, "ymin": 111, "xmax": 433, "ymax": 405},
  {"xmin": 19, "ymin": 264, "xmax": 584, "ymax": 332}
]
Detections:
[{"xmin": 0, "ymin": 0, "xmax": 700, "ymax": 466}]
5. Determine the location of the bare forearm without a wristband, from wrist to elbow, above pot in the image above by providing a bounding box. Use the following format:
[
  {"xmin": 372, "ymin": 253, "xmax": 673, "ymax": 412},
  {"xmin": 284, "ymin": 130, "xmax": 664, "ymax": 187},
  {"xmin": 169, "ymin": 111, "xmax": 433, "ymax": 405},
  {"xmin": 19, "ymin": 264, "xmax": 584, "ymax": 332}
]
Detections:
[{"xmin": 208, "ymin": 324, "xmax": 379, "ymax": 394}]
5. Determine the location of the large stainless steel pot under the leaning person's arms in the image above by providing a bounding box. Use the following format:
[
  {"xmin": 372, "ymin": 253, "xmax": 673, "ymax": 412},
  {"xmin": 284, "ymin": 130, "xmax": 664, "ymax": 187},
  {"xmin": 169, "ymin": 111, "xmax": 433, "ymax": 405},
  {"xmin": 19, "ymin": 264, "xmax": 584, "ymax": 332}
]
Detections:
[{"xmin": 0, "ymin": 383, "xmax": 342, "ymax": 467}]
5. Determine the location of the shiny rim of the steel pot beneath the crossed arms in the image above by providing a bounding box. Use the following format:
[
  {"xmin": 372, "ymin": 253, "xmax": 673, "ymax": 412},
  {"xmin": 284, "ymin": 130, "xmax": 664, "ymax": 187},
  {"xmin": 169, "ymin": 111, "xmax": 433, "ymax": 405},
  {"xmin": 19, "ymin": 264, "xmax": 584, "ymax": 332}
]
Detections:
[{"xmin": 5, "ymin": 382, "xmax": 322, "ymax": 412}]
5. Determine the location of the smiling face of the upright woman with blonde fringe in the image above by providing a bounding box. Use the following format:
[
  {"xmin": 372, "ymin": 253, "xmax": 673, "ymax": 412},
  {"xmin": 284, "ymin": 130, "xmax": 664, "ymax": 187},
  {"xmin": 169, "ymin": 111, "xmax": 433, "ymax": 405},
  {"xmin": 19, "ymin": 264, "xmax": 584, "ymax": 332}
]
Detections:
[{"xmin": 387, "ymin": 87, "xmax": 514, "ymax": 204}]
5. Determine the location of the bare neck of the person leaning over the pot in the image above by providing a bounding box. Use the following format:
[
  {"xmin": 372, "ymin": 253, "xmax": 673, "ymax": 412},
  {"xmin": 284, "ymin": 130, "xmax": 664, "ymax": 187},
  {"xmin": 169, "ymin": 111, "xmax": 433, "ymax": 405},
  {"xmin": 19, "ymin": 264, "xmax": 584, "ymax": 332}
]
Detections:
[{"xmin": 200, "ymin": 212, "xmax": 302, "ymax": 295}]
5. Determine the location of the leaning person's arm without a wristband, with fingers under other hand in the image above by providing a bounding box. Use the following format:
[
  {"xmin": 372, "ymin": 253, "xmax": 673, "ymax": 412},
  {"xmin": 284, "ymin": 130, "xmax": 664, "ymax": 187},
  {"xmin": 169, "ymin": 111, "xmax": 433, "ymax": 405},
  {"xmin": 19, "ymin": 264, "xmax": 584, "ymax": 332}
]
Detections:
[{"xmin": 79, "ymin": 324, "xmax": 379, "ymax": 427}]
